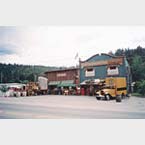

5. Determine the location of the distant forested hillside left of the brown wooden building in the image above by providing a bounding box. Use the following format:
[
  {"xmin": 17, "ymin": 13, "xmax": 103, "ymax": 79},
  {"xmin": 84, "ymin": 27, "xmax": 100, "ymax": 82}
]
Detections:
[{"xmin": 0, "ymin": 63, "xmax": 57, "ymax": 83}]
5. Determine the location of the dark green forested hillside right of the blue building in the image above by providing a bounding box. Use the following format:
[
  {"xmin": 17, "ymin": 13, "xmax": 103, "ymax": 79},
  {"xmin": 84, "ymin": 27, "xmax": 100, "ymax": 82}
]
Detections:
[{"xmin": 115, "ymin": 46, "xmax": 145, "ymax": 95}]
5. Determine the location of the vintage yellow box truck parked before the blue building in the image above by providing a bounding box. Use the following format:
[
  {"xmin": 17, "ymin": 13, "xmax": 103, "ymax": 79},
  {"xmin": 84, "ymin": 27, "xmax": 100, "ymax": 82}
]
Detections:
[{"xmin": 96, "ymin": 77, "xmax": 127, "ymax": 102}]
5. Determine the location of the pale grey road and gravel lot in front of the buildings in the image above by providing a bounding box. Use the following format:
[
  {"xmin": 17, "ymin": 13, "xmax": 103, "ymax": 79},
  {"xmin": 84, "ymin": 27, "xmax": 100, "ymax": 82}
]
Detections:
[{"xmin": 0, "ymin": 95, "xmax": 145, "ymax": 119}]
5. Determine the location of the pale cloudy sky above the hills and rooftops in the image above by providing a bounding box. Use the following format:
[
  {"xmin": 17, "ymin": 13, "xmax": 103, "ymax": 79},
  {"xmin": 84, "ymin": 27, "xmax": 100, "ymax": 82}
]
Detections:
[{"xmin": 0, "ymin": 26, "xmax": 145, "ymax": 67}]
